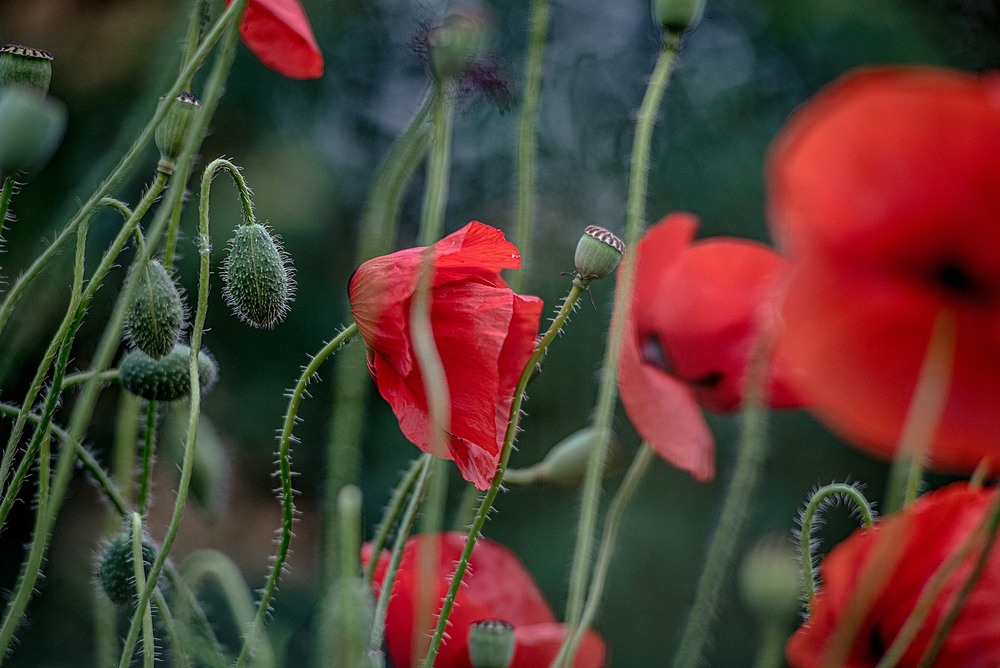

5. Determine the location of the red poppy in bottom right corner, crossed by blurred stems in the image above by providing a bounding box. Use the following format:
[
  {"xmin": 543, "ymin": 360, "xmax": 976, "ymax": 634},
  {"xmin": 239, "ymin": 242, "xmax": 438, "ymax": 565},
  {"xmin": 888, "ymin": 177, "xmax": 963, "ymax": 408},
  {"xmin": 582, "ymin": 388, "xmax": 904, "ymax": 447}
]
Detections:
[{"xmin": 785, "ymin": 483, "xmax": 1000, "ymax": 668}]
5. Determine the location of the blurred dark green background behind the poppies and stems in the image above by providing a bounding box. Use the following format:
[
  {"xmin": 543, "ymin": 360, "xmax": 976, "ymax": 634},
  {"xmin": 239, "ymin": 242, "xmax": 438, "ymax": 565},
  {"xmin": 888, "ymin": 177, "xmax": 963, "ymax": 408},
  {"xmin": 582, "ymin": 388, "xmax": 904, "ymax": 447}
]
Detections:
[{"xmin": 0, "ymin": 0, "xmax": 1000, "ymax": 667}]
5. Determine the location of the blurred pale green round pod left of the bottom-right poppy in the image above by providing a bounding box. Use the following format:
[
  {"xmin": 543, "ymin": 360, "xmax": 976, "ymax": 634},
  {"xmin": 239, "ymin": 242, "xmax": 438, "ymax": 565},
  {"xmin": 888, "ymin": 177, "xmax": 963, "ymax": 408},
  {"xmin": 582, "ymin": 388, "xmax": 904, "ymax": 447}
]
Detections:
[{"xmin": 740, "ymin": 535, "xmax": 802, "ymax": 625}]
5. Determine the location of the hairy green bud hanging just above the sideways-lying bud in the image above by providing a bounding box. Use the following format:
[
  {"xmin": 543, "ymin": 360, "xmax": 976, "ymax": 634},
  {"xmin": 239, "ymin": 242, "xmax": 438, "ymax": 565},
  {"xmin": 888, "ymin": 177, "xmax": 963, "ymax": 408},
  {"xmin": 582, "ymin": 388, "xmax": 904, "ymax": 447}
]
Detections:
[{"xmin": 125, "ymin": 260, "xmax": 185, "ymax": 359}]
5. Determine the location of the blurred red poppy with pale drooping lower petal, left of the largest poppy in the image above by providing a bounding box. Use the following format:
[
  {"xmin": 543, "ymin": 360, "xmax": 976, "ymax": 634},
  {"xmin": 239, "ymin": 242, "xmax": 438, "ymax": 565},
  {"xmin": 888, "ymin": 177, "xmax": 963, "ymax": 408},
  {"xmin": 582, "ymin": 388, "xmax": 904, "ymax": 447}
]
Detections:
[{"xmin": 618, "ymin": 213, "xmax": 798, "ymax": 480}]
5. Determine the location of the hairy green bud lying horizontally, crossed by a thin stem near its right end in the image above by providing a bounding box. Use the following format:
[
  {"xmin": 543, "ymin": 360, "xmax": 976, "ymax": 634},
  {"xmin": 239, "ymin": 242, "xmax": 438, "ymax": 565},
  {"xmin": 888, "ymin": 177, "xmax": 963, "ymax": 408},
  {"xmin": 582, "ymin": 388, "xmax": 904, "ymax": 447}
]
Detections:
[{"xmin": 118, "ymin": 343, "xmax": 219, "ymax": 401}]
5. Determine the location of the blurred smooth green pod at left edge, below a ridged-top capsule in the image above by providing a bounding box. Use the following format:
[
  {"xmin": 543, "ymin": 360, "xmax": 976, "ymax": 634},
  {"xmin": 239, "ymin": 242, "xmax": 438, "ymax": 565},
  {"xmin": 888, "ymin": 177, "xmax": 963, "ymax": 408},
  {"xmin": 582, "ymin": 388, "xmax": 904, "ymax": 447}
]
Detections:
[{"xmin": 0, "ymin": 86, "xmax": 66, "ymax": 176}]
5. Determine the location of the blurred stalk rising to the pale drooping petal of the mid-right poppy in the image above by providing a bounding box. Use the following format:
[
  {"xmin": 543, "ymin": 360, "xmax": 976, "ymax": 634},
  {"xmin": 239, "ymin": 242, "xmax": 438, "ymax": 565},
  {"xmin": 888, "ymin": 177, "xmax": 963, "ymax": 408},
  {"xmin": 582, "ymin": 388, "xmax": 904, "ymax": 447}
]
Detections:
[{"xmin": 553, "ymin": 443, "xmax": 656, "ymax": 665}]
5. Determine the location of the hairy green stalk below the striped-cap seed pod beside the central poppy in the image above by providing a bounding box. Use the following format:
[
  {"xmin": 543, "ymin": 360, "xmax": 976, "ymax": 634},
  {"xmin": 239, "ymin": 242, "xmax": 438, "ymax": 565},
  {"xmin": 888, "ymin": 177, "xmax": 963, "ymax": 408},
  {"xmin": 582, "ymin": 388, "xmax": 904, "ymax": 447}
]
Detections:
[{"xmin": 423, "ymin": 277, "xmax": 589, "ymax": 668}]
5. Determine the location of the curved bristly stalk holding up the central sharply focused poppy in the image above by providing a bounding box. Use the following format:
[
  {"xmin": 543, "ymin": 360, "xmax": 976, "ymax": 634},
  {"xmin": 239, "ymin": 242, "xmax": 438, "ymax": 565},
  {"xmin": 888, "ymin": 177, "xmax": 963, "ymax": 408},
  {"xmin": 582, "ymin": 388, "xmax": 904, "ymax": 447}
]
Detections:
[{"xmin": 236, "ymin": 323, "xmax": 358, "ymax": 666}]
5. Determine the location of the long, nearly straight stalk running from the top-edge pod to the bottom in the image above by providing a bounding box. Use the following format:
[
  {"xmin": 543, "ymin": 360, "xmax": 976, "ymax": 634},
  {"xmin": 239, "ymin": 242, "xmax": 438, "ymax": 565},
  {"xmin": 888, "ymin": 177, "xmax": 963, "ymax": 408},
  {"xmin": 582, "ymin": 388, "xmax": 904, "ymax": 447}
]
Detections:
[{"xmin": 566, "ymin": 35, "xmax": 680, "ymax": 644}]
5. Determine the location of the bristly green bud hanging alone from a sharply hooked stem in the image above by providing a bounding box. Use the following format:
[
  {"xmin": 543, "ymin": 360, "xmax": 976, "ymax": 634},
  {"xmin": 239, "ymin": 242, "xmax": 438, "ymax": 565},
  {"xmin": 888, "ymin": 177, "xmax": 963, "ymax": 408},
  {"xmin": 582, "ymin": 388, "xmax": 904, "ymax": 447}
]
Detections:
[{"xmin": 222, "ymin": 223, "xmax": 295, "ymax": 327}]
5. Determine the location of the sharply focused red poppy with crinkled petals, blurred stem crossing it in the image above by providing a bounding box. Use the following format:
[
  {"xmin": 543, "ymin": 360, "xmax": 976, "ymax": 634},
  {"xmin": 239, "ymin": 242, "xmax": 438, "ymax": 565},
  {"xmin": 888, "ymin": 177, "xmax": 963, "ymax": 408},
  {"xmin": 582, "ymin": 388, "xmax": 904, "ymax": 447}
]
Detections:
[{"xmin": 348, "ymin": 222, "xmax": 542, "ymax": 489}]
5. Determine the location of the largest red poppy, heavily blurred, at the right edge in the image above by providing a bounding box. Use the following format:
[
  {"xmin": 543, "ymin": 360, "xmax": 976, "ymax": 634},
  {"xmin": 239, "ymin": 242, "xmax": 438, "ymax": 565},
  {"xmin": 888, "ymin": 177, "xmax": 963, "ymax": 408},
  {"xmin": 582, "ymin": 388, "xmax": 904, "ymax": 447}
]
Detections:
[{"xmin": 769, "ymin": 68, "xmax": 1000, "ymax": 472}]
